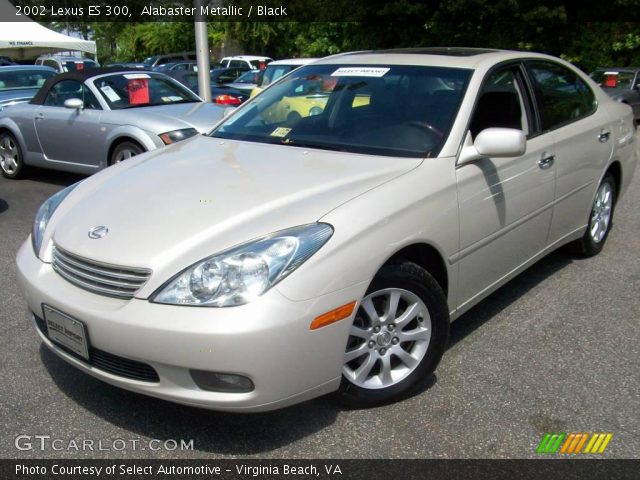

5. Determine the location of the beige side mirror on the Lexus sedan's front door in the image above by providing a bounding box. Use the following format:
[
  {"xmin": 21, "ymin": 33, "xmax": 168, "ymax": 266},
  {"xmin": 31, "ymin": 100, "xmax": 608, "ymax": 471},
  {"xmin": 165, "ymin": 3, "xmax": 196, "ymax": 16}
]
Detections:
[{"xmin": 458, "ymin": 128, "xmax": 527, "ymax": 165}]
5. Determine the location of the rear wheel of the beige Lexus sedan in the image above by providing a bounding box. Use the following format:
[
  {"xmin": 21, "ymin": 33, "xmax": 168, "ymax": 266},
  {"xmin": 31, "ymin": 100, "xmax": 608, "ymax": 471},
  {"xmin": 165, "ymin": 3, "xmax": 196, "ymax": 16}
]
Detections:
[{"xmin": 574, "ymin": 173, "xmax": 616, "ymax": 257}]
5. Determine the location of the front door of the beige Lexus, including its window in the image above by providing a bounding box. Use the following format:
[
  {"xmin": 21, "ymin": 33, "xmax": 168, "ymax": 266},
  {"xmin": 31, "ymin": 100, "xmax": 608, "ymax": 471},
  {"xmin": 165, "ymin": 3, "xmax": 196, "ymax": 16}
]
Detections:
[{"xmin": 455, "ymin": 64, "xmax": 555, "ymax": 309}]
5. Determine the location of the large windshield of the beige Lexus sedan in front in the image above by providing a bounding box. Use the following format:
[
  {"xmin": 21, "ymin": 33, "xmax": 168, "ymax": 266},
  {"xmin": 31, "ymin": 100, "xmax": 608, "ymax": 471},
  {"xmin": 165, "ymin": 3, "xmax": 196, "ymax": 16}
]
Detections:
[{"xmin": 210, "ymin": 65, "xmax": 471, "ymax": 157}]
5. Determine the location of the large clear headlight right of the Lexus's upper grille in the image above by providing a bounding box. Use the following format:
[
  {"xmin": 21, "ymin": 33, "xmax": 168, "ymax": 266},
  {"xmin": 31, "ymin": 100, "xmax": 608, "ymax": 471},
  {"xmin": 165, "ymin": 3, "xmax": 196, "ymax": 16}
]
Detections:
[{"xmin": 151, "ymin": 223, "xmax": 333, "ymax": 307}]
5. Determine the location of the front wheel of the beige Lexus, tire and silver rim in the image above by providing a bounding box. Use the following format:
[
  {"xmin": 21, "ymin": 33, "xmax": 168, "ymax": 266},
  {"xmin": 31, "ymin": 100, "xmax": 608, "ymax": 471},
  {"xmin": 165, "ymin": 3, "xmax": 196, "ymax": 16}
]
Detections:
[{"xmin": 338, "ymin": 261, "xmax": 449, "ymax": 407}]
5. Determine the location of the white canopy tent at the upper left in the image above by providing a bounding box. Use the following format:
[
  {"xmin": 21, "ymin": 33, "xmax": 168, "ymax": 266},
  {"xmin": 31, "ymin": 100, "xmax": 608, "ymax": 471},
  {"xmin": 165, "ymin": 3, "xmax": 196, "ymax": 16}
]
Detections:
[{"xmin": 0, "ymin": 21, "xmax": 96, "ymax": 60}]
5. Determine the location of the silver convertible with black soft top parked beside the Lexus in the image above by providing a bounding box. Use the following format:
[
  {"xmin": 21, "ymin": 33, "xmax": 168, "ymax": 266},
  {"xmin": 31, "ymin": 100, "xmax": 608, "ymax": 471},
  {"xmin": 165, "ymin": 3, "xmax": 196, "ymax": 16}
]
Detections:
[{"xmin": 0, "ymin": 69, "xmax": 224, "ymax": 178}]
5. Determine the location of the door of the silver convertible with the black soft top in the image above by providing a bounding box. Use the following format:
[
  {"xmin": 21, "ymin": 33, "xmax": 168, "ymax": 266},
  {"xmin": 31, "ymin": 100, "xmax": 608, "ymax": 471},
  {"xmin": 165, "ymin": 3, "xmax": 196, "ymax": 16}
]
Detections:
[{"xmin": 33, "ymin": 80, "xmax": 105, "ymax": 167}]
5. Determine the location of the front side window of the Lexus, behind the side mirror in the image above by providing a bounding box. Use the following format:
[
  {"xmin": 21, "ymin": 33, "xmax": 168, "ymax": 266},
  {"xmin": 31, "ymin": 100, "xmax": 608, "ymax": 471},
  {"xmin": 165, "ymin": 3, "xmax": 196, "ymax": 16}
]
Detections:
[{"xmin": 469, "ymin": 67, "xmax": 529, "ymax": 139}]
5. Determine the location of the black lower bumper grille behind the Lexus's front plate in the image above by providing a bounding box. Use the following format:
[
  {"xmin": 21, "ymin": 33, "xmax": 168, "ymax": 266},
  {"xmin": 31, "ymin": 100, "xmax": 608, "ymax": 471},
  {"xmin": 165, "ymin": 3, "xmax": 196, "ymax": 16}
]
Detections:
[{"xmin": 33, "ymin": 315, "xmax": 160, "ymax": 382}]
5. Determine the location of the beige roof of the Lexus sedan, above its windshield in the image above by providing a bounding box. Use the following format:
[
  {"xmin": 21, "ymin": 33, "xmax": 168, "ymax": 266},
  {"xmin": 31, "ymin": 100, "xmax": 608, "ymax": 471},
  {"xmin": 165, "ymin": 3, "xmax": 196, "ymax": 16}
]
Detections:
[{"xmin": 316, "ymin": 47, "xmax": 558, "ymax": 69}]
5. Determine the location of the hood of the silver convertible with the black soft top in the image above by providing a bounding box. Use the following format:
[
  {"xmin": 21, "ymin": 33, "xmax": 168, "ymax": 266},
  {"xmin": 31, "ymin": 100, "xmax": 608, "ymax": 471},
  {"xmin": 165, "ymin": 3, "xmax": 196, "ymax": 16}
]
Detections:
[{"xmin": 103, "ymin": 102, "xmax": 224, "ymax": 134}]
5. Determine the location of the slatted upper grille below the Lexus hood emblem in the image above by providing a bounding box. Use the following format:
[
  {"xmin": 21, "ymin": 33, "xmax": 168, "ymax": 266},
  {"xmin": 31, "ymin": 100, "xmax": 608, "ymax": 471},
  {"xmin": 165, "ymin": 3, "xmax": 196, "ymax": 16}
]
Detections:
[{"xmin": 51, "ymin": 247, "xmax": 151, "ymax": 299}]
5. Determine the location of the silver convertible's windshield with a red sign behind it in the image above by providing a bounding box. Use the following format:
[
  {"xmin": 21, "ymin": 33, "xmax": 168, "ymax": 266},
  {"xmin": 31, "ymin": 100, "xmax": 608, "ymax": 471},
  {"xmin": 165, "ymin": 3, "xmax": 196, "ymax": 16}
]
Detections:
[{"xmin": 93, "ymin": 73, "xmax": 200, "ymax": 110}]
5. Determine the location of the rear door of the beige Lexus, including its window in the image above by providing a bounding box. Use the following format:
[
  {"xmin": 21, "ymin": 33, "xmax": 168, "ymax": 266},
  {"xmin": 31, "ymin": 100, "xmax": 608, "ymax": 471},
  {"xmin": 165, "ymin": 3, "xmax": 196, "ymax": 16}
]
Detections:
[{"xmin": 526, "ymin": 60, "xmax": 613, "ymax": 243}]
